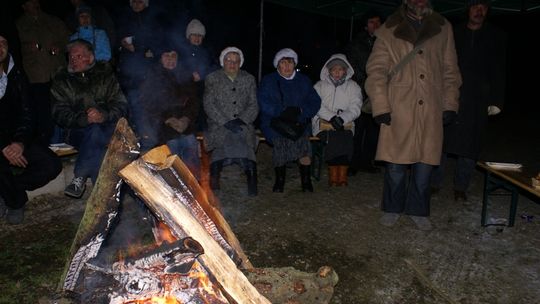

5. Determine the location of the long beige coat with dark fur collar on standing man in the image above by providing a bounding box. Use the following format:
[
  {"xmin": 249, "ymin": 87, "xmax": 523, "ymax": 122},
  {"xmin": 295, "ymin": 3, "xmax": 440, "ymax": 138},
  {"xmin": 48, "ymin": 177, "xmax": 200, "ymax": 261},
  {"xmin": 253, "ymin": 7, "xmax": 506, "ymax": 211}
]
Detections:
[{"xmin": 366, "ymin": 8, "xmax": 461, "ymax": 165}]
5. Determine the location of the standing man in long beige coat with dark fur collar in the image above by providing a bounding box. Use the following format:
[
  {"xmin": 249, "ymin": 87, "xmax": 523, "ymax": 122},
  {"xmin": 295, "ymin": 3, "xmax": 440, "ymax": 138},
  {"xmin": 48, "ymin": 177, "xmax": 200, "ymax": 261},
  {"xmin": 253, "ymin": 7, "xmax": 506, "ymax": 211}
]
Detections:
[{"xmin": 366, "ymin": 0, "xmax": 461, "ymax": 230}]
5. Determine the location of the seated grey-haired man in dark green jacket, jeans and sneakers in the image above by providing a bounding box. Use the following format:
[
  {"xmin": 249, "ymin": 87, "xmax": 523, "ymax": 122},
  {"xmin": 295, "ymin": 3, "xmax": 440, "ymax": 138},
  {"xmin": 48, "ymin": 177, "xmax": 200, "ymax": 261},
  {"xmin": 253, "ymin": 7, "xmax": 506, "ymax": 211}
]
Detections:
[{"xmin": 51, "ymin": 39, "xmax": 127, "ymax": 198}]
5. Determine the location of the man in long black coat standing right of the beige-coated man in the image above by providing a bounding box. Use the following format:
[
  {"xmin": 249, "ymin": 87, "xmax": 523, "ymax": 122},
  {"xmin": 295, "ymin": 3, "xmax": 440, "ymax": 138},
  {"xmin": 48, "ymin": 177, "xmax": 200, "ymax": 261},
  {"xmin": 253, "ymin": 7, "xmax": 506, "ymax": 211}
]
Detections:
[{"xmin": 432, "ymin": 0, "xmax": 506, "ymax": 201}]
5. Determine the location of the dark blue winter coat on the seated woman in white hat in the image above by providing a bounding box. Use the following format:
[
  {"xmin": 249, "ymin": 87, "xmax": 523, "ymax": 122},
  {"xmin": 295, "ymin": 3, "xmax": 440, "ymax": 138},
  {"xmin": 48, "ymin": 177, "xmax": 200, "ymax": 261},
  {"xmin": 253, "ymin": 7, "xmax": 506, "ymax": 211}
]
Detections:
[{"xmin": 257, "ymin": 71, "xmax": 321, "ymax": 143}]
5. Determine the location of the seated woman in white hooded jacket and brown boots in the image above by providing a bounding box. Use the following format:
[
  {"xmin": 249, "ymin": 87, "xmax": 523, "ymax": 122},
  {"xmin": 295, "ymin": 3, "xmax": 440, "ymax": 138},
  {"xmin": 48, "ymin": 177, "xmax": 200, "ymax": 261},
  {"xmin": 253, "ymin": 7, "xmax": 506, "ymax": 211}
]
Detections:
[{"xmin": 312, "ymin": 54, "xmax": 362, "ymax": 186}]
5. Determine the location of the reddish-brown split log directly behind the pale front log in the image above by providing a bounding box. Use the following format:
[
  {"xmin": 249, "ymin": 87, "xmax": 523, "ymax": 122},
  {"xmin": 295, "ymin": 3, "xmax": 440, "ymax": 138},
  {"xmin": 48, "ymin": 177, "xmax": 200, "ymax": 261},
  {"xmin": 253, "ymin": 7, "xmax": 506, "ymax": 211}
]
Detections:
[{"xmin": 142, "ymin": 145, "xmax": 253, "ymax": 270}]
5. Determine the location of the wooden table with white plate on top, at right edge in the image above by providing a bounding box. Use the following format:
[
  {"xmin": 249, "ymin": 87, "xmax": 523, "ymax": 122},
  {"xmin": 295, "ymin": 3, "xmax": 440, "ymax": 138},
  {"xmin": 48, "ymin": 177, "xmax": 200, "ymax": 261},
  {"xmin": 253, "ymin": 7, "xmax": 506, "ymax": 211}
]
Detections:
[{"xmin": 477, "ymin": 162, "xmax": 540, "ymax": 227}]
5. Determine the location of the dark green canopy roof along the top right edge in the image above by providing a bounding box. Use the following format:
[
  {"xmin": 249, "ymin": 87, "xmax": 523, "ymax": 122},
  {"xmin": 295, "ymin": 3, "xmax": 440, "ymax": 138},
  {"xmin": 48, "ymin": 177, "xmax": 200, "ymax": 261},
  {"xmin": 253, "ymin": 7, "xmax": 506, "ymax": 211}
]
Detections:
[{"xmin": 265, "ymin": 0, "xmax": 540, "ymax": 19}]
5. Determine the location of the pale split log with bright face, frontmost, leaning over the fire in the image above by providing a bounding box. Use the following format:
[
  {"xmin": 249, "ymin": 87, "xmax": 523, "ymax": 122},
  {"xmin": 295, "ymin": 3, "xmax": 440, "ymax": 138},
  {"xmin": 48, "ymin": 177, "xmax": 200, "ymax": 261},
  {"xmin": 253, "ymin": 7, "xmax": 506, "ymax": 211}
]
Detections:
[{"xmin": 120, "ymin": 159, "xmax": 270, "ymax": 304}]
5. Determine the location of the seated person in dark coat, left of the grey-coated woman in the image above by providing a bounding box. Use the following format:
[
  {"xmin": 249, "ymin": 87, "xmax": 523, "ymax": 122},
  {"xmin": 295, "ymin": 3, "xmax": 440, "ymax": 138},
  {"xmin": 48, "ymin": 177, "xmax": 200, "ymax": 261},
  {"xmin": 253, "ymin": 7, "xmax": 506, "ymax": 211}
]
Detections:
[{"xmin": 138, "ymin": 47, "xmax": 200, "ymax": 179}]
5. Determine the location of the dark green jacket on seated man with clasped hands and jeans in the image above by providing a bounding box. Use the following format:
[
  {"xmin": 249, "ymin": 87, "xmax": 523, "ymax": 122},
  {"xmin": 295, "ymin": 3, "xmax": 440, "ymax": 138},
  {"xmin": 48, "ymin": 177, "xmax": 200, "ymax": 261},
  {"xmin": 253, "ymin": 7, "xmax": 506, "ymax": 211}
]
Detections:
[{"xmin": 51, "ymin": 62, "xmax": 128, "ymax": 128}]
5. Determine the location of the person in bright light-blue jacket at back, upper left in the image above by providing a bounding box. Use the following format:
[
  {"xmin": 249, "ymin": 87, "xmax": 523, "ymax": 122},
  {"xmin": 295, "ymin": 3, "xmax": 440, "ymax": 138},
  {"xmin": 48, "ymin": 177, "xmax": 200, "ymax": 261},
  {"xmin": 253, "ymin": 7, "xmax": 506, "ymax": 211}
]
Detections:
[{"xmin": 69, "ymin": 4, "xmax": 111, "ymax": 61}]
